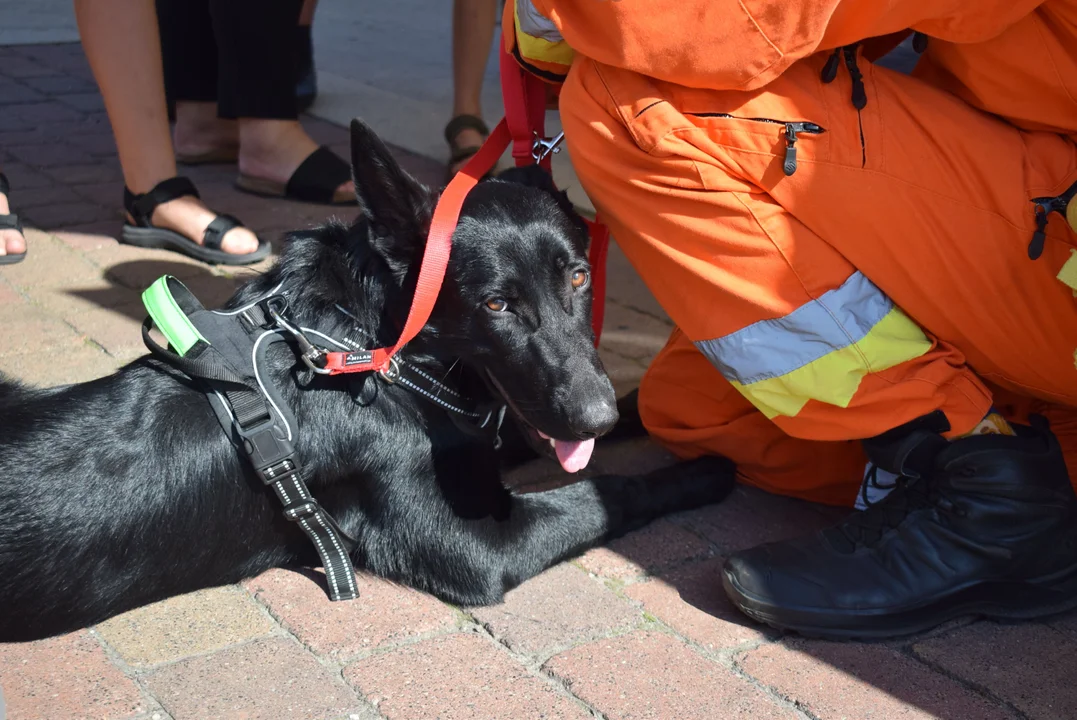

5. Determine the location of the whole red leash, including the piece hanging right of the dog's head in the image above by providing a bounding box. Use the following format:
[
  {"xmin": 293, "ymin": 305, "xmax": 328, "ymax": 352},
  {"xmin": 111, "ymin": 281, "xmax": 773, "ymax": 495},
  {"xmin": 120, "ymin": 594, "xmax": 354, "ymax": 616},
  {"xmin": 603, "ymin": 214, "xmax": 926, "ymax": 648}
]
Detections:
[{"xmin": 325, "ymin": 43, "xmax": 610, "ymax": 375}]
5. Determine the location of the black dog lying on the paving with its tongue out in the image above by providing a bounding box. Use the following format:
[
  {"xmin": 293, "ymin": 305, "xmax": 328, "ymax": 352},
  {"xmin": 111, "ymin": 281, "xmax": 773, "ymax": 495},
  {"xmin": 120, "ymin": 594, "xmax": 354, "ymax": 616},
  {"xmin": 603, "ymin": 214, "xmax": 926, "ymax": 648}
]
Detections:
[{"xmin": 0, "ymin": 122, "xmax": 732, "ymax": 641}]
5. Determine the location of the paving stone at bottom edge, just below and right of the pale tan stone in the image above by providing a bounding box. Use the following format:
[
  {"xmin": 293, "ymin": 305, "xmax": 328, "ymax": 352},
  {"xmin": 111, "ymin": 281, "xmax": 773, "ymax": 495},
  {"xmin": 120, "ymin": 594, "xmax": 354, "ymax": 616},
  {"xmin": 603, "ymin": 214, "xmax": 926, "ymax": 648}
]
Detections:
[{"xmin": 142, "ymin": 638, "xmax": 363, "ymax": 720}]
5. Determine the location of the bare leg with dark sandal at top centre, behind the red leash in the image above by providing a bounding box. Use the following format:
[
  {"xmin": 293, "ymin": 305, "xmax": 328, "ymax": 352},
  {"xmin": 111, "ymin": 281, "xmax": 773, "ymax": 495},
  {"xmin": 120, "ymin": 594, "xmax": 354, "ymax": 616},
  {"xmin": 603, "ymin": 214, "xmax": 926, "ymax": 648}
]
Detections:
[{"xmin": 452, "ymin": 0, "xmax": 498, "ymax": 171}]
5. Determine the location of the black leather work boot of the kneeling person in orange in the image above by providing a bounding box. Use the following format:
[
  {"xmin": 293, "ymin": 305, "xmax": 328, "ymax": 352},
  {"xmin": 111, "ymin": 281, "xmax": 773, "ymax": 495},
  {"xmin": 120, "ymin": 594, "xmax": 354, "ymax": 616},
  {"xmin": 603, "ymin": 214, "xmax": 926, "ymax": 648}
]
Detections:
[{"xmin": 723, "ymin": 414, "xmax": 1077, "ymax": 638}]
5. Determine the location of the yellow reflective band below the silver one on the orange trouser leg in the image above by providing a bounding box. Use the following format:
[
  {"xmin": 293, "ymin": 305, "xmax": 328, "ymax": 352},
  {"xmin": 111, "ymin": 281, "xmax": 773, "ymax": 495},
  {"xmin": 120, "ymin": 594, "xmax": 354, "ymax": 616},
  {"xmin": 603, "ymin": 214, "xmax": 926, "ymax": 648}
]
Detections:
[{"xmin": 731, "ymin": 307, "xmax": 932, "ymax": 420}]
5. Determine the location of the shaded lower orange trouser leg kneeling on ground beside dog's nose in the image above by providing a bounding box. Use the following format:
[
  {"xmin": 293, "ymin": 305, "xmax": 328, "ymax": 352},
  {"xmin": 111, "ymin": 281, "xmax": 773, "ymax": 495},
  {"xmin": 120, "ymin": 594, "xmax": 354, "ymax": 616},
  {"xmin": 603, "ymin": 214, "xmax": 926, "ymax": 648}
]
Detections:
[{"xmin": 640, "ymin": 329, "xmax": 867, "ymax": 506}]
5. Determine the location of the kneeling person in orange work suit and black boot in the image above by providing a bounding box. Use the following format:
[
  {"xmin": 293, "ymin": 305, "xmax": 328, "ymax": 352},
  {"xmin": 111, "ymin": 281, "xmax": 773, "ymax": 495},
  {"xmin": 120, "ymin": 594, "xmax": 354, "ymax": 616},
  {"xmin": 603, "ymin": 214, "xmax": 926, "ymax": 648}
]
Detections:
[{"xmin": 504, "ymin": 0, "xmax": 1077, "ymax": 637}]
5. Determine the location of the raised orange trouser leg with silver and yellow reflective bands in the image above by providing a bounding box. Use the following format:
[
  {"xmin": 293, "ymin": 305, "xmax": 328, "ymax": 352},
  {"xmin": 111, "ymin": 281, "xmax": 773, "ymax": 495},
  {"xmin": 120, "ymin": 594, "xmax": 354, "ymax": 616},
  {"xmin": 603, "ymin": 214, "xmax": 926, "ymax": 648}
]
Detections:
[{"xmin": 560, "ymin": 50, "xmax": 1077, "ymax": 440}]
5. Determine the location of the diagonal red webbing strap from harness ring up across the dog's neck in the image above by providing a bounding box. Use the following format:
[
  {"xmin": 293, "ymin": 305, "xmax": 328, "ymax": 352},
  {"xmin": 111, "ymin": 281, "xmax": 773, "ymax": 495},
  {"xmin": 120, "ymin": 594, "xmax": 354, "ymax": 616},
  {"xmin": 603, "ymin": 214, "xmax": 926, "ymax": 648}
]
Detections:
[{"xmin": 325, "ymin": 119, "xmax": 509, "ymax": 375}]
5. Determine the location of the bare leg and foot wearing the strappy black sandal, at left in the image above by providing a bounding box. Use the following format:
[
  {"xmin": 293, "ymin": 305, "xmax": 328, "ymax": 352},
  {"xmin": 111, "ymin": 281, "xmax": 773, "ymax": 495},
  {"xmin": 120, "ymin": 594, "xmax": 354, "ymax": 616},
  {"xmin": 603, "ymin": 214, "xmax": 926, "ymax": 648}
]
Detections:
[{"xmin": 74, "ymin": 0, "xmax": 257, "ymax": 254}]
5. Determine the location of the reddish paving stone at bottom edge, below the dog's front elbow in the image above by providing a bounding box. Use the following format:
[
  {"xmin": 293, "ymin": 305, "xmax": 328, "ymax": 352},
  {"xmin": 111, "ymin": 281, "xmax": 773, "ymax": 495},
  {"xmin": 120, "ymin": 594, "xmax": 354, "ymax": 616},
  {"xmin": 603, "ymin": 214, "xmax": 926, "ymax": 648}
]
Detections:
[{"xmin": 344, "ymin": 634, "xmax": 591, "ymax": 720}]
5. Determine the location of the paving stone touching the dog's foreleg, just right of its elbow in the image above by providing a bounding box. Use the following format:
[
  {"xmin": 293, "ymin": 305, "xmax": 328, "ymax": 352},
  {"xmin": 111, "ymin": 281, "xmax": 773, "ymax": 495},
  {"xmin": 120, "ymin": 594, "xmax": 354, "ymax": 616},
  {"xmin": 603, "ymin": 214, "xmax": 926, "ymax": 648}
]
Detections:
[{"xmin": 472, "ymin": 563, "xmax": 642, "ymax": 658}]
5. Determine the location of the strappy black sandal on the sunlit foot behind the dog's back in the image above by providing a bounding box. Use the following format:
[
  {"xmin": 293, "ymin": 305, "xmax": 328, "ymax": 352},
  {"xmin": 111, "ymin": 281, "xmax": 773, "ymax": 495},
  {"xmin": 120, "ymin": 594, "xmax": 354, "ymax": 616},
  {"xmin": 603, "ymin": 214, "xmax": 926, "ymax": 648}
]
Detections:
[{"xmin": 122, "ymin": 178, "xmax": 270, "ymax": 265}]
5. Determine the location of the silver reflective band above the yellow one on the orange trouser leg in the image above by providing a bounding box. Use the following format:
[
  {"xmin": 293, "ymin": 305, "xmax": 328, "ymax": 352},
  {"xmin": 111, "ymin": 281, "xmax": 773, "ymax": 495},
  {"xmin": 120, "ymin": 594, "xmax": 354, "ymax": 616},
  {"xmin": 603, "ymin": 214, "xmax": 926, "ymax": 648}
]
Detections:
[{"xmin": 696, "ymin": 271, "xmax": 894, "ymax": 385}]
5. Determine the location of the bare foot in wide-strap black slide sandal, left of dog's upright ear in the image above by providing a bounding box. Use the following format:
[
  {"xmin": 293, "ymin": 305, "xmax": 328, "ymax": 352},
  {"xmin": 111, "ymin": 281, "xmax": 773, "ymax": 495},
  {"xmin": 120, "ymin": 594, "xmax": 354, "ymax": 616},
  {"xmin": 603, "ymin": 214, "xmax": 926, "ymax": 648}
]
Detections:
[{"xmin": 239, "ymin": 117, "xmax": 355, "ymax": 197}]
